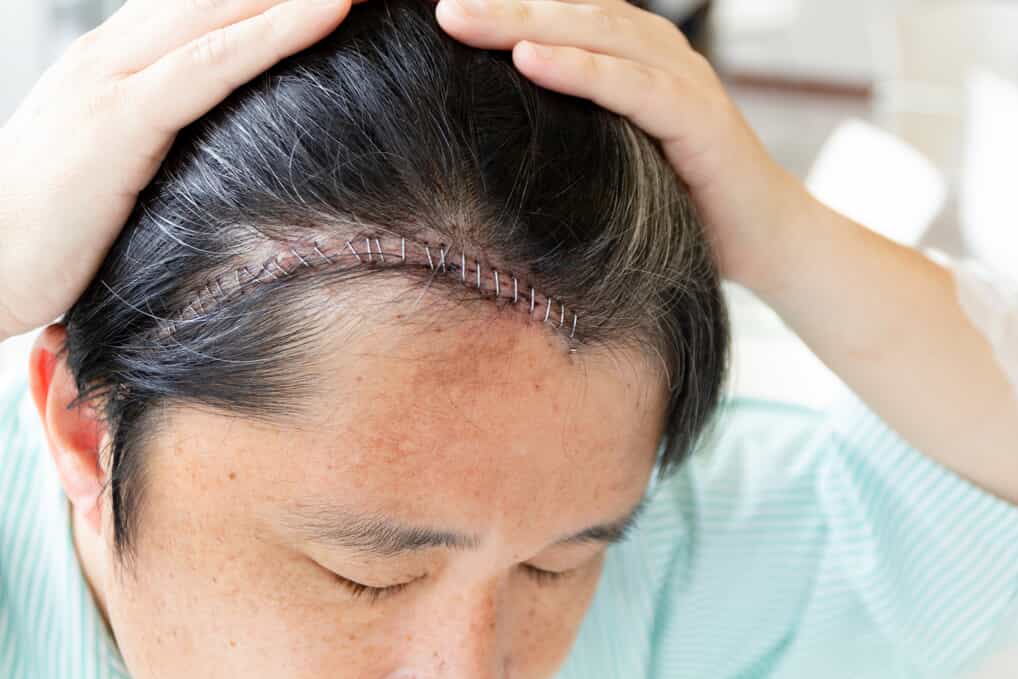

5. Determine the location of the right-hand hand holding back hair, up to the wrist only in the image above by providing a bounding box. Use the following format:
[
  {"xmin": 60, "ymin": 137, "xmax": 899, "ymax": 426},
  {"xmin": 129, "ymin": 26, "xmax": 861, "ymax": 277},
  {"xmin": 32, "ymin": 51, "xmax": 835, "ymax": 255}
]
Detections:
[{"xmin": 436, "ymin": 0, "xmax": 816, "ymax": 292}]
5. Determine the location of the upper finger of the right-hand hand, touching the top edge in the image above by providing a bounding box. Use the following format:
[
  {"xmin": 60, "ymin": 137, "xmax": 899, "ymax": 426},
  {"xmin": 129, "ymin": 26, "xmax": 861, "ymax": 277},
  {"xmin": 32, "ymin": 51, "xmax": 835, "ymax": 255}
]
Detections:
[{"xmin": 436, "ymin": 0, "xmax": 688, "ymax": 74}]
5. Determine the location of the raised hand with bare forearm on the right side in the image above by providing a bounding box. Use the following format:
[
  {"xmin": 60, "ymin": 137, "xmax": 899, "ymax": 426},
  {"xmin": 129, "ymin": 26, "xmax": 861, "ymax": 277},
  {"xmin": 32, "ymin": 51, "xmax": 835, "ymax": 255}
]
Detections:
[{"xmin": 436, "ymin": 0, "xmax": 1018, "ymax": 505}]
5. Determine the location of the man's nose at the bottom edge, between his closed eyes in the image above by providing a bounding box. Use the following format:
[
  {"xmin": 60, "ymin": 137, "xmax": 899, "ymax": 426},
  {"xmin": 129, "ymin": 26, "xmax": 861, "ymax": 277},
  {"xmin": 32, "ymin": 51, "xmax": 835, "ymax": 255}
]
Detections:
[{"xmin": 385, "ymin": 578, "xmax": 510, "ymax": 679}]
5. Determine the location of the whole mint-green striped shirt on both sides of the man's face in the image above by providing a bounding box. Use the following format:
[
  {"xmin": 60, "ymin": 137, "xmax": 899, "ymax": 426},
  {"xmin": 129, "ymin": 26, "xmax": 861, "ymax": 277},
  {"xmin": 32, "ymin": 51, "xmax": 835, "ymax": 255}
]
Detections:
[{"xmin": 0, "ymin": 380, "xmax": 1018, "ymax": 679}]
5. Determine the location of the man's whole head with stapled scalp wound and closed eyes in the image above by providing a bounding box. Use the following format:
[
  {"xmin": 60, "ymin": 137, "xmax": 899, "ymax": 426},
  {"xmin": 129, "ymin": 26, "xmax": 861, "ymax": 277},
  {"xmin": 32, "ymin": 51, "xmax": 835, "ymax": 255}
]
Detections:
[{"xmin": 32, "ymin": 0, "xmax": 728, "ymax": 679}]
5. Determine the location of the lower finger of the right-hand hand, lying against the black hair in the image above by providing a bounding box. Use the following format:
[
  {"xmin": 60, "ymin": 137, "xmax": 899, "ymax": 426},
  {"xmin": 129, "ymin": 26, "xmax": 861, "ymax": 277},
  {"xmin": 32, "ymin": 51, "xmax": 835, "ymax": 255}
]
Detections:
[{"xmin": 512, "ymin": 41, "xmax": 708, "ymax": 143}]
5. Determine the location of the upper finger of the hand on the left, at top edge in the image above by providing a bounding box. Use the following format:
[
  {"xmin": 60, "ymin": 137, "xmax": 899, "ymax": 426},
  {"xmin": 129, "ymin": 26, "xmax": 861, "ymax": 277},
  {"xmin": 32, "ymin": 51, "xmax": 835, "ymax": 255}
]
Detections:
[{"xmin": 104, "ymin": 0, "xmax": 349, "ymax": 73}]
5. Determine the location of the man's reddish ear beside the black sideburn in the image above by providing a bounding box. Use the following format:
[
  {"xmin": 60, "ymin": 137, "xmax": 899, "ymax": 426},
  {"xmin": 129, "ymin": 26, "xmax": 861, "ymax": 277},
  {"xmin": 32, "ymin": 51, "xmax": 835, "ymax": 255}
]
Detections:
[{"xmin": 29, "ymin": 323, "xmax": 105, "ymax": 534}]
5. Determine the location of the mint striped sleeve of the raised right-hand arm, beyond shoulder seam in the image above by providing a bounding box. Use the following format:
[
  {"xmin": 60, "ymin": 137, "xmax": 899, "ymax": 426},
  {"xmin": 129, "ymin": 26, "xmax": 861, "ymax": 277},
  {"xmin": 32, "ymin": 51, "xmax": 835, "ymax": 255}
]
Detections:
[{"xmin": 819, "ymin": 384, "xmax": 1018, "ymax": 676}]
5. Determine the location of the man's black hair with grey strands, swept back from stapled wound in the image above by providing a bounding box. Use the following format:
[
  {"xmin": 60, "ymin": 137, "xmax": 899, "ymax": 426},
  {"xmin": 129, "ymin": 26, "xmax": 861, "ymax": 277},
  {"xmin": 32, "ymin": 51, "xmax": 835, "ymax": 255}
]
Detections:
[{"xmin": 62, "ymin": 0, "xmax": 729, "ymax": 556}]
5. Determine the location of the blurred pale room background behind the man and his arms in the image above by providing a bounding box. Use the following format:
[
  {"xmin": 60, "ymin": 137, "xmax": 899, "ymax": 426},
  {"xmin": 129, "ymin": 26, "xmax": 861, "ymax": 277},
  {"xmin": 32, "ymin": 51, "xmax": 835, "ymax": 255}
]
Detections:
[{"xmin": 0, "ymin": 0, "xmax": 1018, "ymax": 417}]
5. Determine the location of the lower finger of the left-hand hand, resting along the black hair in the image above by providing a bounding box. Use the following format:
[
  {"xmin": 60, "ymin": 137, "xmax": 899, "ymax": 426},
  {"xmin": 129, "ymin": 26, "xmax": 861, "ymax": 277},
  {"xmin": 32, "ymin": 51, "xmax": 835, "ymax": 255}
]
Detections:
[{"xmin": 124, "ymin": 0, "xmax": 349, "ymax": 133}]
